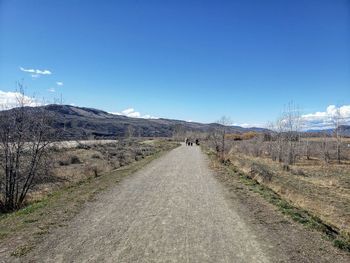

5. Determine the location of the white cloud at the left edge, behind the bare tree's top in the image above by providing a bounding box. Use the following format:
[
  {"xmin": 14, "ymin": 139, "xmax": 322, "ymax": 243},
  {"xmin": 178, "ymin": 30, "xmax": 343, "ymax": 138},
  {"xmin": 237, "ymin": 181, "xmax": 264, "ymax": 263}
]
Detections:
[{"xmin": 0, "ymin": 90, "xmax": 42, "ymax": 110}]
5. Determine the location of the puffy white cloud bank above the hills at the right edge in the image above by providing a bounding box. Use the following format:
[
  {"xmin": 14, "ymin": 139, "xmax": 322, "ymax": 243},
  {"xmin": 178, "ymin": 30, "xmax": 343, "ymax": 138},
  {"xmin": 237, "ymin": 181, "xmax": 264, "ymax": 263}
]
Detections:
[{"xmin": 301, "ymin": 105, "xmax": 350, "ymax": 129}]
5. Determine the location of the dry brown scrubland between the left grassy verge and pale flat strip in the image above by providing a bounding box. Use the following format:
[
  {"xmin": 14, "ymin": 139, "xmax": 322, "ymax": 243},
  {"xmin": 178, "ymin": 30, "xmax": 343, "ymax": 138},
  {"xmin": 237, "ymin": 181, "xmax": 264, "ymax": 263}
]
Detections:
[{"xmin": 27, "ymin": 138, "xmax": 175, "ymax": 203}]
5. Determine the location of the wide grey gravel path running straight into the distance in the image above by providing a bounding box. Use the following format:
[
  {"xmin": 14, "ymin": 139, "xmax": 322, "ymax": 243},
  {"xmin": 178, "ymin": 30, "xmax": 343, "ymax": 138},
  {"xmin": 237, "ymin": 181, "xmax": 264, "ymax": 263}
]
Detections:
[{"xmin": 20, "ymin": 146, "xmax": 350, "ymax": 262}]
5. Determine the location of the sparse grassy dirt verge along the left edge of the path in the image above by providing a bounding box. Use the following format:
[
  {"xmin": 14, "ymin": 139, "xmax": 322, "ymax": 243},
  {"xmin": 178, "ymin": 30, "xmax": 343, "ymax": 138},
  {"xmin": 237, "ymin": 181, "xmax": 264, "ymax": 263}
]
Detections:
[{"xmin": 0, "ymin": 142, "xmax": 176, "ymax": 262}]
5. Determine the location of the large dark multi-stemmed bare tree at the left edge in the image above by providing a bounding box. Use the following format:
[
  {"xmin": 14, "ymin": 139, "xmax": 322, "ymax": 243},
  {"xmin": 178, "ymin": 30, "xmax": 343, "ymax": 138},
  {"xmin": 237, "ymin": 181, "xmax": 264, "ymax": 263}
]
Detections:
[{"xmin": 0, "ymin": 84, "xmax": 57, "ymax": 211}]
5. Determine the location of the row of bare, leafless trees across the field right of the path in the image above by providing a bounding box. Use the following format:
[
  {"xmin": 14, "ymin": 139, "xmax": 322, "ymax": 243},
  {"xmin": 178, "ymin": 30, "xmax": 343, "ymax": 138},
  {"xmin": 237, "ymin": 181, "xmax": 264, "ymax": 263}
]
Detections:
[{"xmin": 207, "ymin": 103, "xmax": 349, "ymax": 165}]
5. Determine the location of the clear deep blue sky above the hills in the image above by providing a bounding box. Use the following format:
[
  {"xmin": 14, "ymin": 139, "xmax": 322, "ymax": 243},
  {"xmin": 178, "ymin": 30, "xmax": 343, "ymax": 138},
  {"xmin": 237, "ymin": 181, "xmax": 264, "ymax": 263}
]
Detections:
[{"xmin": 0, "ymin": 0, "xmax": 350, "ymax": 125}]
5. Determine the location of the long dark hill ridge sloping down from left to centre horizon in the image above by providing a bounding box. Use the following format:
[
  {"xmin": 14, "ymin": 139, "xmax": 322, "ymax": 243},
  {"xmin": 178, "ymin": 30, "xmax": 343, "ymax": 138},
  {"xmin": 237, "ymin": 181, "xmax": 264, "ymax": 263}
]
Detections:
[{"xmin": 4, "ymin": 104, "xmax": 267, "ymax": 139}]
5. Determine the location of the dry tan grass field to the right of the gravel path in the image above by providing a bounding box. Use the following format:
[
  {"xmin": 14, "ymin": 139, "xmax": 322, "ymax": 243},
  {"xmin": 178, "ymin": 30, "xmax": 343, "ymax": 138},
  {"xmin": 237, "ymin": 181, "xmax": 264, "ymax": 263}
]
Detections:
[{"xmin": 224, "ymin": 138, "xmax": 350, "ymax": 242}]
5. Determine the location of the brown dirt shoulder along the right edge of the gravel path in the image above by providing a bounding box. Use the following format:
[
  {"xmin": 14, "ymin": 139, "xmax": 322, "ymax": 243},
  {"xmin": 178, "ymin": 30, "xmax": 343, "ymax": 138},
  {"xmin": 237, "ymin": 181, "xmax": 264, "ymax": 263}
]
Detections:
[{"xmin": 211, "ymin": 154, "xmax": 350, "ymax": 262}]
